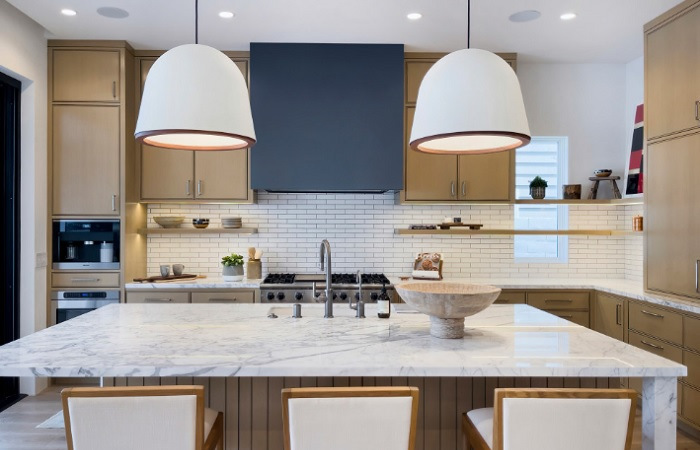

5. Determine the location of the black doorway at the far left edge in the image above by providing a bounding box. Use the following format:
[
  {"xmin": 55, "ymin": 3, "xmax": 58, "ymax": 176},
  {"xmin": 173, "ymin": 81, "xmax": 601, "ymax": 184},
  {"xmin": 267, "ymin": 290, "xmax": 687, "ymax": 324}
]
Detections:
[{"xmin": 0, "ymin": 73, "xmax": 22, "ymax": 411}]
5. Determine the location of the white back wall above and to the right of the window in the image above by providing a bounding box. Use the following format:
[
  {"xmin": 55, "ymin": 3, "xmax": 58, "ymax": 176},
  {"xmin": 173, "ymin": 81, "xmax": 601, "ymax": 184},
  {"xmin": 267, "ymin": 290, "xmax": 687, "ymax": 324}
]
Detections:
[{"xmin": 518, "ymin": 63, "xmax": 627, "ymax": 198}]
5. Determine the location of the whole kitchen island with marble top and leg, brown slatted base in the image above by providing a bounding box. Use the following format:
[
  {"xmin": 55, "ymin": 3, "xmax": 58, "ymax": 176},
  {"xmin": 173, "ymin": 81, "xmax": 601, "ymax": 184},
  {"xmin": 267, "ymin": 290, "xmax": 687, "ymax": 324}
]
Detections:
[{"xmin": 0, "ymin": 304, "xmax": 687, "ymax": 450}]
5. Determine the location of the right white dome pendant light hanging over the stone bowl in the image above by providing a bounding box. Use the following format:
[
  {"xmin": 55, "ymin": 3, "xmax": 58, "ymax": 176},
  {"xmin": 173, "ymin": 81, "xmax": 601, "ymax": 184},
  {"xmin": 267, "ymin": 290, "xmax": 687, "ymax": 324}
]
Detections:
[{"xmin": 409, "ymin": 0, "xmax": 530, "ymax": 155}]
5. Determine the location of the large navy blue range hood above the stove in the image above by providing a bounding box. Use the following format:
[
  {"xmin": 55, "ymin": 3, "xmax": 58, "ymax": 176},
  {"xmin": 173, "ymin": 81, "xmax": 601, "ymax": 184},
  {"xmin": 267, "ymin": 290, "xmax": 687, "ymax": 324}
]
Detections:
[{"xmin": 250, "ymin": 43, "xmax": 404, "ymax": 192}]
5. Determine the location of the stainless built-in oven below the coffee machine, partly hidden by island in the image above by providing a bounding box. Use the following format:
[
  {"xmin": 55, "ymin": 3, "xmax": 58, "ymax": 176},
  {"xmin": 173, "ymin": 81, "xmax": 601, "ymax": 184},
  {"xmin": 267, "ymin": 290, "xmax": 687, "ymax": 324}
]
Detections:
[{"xmin": 51, "ymin": 289, "xmax": 120, "ymax": 325}]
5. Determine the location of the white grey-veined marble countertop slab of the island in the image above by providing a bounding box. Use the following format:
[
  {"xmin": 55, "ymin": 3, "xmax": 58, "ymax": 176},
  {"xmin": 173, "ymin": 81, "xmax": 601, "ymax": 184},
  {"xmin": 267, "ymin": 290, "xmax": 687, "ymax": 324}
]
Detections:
[{"xmin": 0, "ymin": 304, "xmax": 687, "ymax": 377}]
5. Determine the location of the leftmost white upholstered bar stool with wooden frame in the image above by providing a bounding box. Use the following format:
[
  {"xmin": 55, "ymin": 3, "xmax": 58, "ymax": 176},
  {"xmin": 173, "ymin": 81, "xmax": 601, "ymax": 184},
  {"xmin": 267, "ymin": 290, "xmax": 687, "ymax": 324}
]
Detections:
[{"xmin": 61, "ymin": 386, "xmax": 224, "ymax": 450}]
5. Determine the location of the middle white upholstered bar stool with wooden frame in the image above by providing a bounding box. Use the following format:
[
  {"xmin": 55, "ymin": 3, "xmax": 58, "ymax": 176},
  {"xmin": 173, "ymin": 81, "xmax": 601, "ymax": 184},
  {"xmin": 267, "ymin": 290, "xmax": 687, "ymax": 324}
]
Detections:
[{"xmin": 282, "ymin": 387, "xmax": 418, "ymax": 450}]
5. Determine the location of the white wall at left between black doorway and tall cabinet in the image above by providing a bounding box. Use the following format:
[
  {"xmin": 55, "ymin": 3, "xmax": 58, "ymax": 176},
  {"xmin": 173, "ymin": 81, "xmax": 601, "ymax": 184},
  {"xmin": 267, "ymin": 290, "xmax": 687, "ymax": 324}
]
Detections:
[{"xmin": 0, "ymin": 0, "xmax": 47, "ymax": 394}]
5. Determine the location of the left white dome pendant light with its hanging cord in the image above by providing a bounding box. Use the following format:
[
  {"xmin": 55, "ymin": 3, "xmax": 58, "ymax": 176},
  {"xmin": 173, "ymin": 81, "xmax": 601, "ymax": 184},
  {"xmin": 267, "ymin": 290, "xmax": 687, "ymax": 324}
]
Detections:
[{"xmin": 134, "ymin": 3, "xmax": 256, "ymax": 150}]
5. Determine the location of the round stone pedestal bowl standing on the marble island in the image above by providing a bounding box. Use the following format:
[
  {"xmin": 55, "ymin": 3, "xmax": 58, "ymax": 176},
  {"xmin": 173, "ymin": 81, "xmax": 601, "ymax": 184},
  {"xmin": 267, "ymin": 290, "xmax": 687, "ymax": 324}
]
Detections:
[{"xmin": 395, "ymin": 281, "xmax": 501, "ymax": 339}]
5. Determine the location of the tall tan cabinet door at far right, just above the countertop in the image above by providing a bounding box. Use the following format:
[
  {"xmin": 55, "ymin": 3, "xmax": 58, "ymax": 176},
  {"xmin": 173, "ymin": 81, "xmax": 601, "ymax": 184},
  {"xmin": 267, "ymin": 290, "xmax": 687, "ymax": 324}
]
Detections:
[{"xmin": 644, "ymin": 134, "xmax": 700, "ymax": 297}]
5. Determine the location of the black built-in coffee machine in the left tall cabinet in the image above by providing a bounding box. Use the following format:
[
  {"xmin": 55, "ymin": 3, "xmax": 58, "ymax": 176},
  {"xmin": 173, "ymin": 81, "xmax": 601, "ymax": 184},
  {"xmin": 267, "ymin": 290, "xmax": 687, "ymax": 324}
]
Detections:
[{"xmin": 51, "ymin": 219, "xmax": 120, "ymax": 270}]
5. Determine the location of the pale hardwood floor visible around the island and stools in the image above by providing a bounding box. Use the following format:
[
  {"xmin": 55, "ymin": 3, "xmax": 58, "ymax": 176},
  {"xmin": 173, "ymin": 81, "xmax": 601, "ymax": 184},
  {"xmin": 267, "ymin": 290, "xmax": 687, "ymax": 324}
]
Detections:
[{"xmin": 0, "ymin": 387, "xmax": 700, "ymax": 450}]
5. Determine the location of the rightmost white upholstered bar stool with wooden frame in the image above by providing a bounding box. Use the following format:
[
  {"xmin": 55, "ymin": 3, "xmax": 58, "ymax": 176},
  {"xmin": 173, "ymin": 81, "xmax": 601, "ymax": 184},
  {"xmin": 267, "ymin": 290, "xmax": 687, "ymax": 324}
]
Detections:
[{"xmin": 462, "ymin": 388, "xmax": 637, "ymax": 450}]
